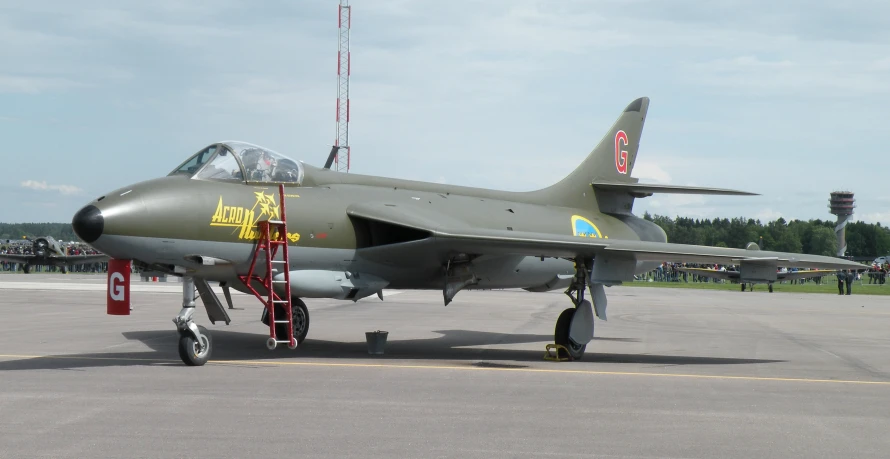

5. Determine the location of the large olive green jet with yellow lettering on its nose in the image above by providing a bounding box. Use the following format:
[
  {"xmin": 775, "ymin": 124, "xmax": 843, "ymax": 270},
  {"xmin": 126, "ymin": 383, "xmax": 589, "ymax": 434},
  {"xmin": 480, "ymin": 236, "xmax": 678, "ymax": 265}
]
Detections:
[{"xmin": 72, "ymin": 98, "xmax": 860, "ymax": 365}]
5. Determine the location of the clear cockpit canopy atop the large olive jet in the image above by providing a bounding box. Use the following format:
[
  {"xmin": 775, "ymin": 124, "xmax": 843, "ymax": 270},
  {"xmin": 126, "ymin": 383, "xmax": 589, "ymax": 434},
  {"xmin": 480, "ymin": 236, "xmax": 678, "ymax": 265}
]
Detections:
[{"xmin": 169, "ymin": 141, "xmax": 303, "ymax": 185}]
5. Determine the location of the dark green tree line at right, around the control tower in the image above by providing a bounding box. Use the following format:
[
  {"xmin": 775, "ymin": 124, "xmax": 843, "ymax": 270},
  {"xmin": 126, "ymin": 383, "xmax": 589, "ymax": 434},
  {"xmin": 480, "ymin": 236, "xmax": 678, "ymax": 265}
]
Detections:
[{"xmin": 643, "ymin": 212, "xmax": 890, "ymax": 257}]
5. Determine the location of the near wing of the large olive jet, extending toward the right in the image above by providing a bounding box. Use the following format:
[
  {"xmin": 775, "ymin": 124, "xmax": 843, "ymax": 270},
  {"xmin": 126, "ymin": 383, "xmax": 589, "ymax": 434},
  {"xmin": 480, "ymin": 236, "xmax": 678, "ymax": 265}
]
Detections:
[{"xmin": 347, "ymin": 203, "xmax": 863, "ymax": 269}]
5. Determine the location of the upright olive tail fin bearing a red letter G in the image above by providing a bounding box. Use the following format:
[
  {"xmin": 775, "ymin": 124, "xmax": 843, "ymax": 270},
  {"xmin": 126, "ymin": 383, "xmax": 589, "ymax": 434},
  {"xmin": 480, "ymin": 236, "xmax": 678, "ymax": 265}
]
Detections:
[{"xmin": 539, "ymin": 97, "xmax": 649, "ymax": 207}]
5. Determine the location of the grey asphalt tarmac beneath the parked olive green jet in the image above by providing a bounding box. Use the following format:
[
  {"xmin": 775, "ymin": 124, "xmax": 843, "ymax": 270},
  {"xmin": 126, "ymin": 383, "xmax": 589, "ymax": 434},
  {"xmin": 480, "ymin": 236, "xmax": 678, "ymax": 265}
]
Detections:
[{"xmin": 0, "ymin": 274, "xmax": 890, "ymax": 458}]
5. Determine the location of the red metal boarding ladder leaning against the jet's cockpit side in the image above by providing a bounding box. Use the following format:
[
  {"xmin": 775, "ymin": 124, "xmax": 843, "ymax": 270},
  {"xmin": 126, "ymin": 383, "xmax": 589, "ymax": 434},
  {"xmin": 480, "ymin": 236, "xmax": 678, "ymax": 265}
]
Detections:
[{"xmin": 238, "ymin": 185, "xmax": 297, "ymax": 349}]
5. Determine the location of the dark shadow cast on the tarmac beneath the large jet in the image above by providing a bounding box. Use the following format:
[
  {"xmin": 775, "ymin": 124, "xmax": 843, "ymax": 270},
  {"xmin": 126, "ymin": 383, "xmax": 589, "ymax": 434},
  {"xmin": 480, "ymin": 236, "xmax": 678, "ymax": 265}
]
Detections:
[{"xmin": 0, "ymin": 330, "xmax": 783, "ymax": 371}]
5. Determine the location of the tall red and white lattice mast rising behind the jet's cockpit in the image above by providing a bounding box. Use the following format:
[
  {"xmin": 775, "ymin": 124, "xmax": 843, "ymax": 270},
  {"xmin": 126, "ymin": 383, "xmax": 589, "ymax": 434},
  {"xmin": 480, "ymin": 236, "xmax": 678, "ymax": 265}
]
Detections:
[{"xmin": 328, "ymin": 0, "xmax": 352, "ymax": 172}]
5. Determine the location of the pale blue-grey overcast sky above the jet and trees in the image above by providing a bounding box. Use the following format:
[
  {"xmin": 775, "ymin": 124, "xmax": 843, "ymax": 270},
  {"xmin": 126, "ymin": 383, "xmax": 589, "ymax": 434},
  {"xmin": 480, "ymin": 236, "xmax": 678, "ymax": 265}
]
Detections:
[{"xmin": 0, "ymin": 0, "xmax": 890, "ymax": 224}]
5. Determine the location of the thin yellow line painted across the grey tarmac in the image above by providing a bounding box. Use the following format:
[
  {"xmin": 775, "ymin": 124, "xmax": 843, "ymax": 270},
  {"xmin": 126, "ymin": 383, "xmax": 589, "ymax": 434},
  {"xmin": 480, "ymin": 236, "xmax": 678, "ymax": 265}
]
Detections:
[{"xmin": 0, "ymin": 354, "xmax": 890, "ymax": 386}]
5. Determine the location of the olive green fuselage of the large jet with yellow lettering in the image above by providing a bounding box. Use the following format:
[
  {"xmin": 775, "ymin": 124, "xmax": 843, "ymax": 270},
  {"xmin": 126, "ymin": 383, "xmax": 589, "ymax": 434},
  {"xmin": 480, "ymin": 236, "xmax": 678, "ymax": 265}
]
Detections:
[{"xmin": 91, "ymin": 168, "xmax": 664, "ymax": 289}]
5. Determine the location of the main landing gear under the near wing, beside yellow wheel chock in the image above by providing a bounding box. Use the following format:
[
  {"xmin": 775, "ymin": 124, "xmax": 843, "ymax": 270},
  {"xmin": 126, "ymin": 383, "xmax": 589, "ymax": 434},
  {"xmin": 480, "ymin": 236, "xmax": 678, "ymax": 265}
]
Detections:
[{"xmin": 553, "ymin": 260, "xmax": 606, "ymax": 360}]
